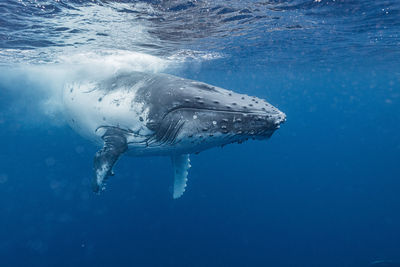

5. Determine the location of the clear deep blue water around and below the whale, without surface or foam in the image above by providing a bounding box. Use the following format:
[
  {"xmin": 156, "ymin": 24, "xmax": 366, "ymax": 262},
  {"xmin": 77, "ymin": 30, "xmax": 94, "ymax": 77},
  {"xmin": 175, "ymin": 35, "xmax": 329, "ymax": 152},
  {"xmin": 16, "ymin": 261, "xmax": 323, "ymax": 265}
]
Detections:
[{"xmin": 0, "ymin": 65, "xmax": 400, "ymax": 266}]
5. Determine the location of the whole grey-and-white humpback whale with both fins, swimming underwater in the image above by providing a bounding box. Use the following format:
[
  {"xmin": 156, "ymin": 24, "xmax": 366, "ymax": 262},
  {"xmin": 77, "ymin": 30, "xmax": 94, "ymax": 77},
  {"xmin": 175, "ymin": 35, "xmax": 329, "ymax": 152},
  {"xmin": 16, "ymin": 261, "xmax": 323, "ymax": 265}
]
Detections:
[{"xmin": 63, "ymin": 72, "xmax": 286, "ymax": 198}]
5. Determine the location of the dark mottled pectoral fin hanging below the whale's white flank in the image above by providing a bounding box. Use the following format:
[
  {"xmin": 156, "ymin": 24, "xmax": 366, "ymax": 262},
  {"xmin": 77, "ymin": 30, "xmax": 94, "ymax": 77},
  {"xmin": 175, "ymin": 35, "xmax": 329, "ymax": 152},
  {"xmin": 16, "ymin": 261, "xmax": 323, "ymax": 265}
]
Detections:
[{"xmin": 92, "ymin": 128, "xmax": 128, "ymax": 193}]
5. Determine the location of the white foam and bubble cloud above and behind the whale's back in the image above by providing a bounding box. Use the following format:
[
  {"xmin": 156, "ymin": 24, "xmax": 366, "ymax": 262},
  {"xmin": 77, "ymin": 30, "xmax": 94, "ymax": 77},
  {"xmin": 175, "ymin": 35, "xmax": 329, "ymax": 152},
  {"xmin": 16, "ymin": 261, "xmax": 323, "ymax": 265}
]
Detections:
[{"xmin": 0, "ymin": 50, "xmax": 173, "ymax": 129}]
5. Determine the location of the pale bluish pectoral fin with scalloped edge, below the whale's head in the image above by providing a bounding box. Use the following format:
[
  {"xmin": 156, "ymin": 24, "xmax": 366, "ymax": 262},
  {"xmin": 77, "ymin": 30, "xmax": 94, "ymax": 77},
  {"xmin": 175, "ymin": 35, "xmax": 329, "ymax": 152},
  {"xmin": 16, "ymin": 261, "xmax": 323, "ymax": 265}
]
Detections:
[{"xmin": 171, "ymin": 154, "xmax": 191, "ymax": 199}]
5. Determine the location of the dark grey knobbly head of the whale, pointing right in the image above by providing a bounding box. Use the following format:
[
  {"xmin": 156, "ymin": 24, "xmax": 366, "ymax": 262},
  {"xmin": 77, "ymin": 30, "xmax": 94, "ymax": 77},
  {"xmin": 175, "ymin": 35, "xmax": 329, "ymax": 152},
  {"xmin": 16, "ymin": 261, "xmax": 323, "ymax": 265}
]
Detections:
[{"xmin": 137, "ymin": 75, "xmax": 286, "ymax": 153}]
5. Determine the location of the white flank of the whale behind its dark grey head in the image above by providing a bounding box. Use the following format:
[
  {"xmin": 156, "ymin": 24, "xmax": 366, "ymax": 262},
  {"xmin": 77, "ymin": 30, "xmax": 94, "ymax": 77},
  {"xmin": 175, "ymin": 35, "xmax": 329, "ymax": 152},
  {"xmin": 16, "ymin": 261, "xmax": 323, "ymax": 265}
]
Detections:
[{"xmin": 63, "ymin": 82, "xmax": 151, "ymax": 144}]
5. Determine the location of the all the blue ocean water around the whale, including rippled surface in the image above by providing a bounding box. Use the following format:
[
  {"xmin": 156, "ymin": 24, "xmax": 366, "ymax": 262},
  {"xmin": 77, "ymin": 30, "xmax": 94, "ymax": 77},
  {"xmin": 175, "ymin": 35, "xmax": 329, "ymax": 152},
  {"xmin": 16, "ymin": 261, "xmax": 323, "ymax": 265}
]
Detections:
[{"xmin": 0, "ymin": 0, "xmax": 400, "ymax": 267}]
